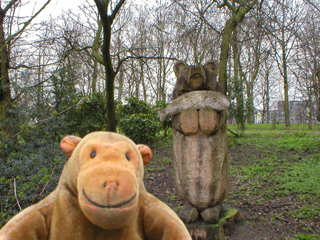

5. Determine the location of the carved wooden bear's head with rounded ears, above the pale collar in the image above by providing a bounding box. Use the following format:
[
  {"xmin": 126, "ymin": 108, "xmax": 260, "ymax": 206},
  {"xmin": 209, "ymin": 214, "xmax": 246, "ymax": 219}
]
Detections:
[{"xmin": 173, "ymin": 60, "xmax": 222, "ymax": 99}]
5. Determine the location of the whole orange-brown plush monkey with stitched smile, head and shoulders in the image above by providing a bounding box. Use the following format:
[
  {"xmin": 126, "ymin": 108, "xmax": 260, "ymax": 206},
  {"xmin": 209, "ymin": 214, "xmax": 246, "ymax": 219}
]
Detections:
[{"xmin": 0, "ymin": 132, "xmax": 191, "ymax": 240}]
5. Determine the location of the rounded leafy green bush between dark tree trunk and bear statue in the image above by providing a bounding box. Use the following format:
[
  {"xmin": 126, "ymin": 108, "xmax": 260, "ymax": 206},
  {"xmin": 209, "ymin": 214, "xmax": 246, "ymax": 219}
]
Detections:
[{"xmin": 118, "ymin": 98, "xmax": 161, "ymax": 144}]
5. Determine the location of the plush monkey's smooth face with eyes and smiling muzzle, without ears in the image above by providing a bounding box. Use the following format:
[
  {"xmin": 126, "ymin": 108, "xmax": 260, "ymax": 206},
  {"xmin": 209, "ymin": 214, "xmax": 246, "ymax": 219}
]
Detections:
[{"xmin": 77, "ymin": 139, "xmax": 142, "ymax": 229}]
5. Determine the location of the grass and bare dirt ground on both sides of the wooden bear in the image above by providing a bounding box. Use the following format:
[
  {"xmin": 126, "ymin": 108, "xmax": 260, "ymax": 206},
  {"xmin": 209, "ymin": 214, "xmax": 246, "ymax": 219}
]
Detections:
[{"xmin": 145, "ymin": 125, "xmax": 320, "ymax": 240}]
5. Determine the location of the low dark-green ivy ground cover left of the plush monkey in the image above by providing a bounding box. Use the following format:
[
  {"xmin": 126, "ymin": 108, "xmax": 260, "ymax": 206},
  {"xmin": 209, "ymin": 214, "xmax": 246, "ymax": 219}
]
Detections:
[{"xmin": 0, "ymin": 137, "xmax": 66, "ymax": 228}]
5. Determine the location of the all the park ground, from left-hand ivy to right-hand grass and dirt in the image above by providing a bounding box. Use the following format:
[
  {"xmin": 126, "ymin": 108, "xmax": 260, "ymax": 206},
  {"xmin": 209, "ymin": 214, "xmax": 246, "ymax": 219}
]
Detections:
[{"xmin": 0, "ymin": 124, "xmax": 320, "ymax": 240}]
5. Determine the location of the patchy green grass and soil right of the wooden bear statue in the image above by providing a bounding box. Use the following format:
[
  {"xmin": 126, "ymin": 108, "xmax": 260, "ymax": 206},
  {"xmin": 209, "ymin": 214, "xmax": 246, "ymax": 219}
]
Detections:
[{"xmin": 226, "ymin": 131, "xmax": 320, "ymax": 240}]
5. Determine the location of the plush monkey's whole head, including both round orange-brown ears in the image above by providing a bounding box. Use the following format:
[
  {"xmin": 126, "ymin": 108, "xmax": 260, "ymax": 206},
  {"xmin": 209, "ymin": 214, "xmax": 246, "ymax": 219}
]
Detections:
[{"xmin": 60, "ymin": 132, "xmax": 152, "ymax": 229}]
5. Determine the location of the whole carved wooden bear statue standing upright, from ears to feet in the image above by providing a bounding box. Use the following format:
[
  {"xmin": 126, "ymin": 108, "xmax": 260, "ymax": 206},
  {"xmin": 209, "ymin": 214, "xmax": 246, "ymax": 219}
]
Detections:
[{"xmin": 159, "ymin": 61, "xmax": 230, "ymax": 223}]
